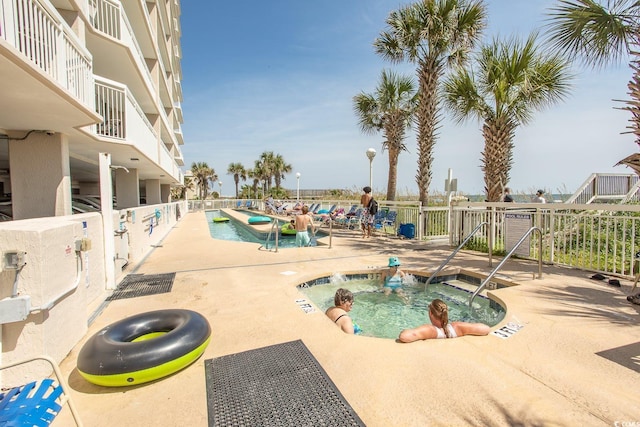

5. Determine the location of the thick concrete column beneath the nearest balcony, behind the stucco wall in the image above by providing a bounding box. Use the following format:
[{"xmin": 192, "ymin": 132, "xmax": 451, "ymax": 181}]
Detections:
[{"xmin": 9, "ymin": 132, "xmax": 72, "ymax": 219}]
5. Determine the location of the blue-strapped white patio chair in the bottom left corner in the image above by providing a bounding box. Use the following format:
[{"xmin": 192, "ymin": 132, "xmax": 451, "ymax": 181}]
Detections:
[{"xmin": 0, "ymin": 356, "xmax": 82, "ymax": 427}]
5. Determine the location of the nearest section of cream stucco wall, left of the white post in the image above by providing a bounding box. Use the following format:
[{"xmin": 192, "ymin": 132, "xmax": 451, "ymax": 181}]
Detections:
[{"xmin": 0, "ymin": 213, "xmax": 105, "ymax": 384}]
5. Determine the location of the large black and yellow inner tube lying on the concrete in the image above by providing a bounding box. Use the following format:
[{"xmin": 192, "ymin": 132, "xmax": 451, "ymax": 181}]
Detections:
[{"xmin": 77, "ymin": 309, "xmax": 211, "ymax": 387}]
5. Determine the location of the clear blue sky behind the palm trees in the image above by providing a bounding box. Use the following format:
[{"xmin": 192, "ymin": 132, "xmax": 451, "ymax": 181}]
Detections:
[{"xmin": 181, "ymin": 0, "xmax": 637, "ymax": 195}]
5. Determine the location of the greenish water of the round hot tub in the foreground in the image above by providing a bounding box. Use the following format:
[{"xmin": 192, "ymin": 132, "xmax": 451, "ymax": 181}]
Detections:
[{"xmin": 298, "ymin": 273, "xmax": 505, "ymax": 339}]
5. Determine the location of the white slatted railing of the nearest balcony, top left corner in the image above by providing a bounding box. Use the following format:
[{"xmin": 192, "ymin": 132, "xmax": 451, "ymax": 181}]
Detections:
[{"xmin": 0, "ymin": 0, "xmax": 93, "ymax": 108}]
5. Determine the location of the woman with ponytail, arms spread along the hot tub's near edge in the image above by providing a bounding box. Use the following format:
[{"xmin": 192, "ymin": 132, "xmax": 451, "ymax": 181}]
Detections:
[{"xmin": 398, "ymin": 299, "xmax": 491, "ymax": 343}]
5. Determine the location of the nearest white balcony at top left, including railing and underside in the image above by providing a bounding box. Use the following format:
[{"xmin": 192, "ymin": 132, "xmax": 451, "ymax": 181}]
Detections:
[{"xmin": 0, "ymin": 0, "xmax": 98, "ymax": 131}]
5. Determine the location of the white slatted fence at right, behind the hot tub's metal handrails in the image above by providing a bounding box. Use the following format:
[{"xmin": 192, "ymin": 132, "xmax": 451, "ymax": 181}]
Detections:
[{"xmin": 450, "ymin": 203, "xmax": 640, "ymax": 277}]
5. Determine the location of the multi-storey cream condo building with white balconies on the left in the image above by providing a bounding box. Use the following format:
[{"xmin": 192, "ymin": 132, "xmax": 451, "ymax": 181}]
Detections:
[{"xmin": 0, "ymin": 0, "xmax": 187, "ymax": 379}]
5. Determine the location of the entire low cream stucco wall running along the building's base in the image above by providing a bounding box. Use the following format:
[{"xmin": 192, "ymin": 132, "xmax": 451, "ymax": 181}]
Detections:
[{"xmin": 0, "ymin": 202, "xmax": 187, "ymax": 387}]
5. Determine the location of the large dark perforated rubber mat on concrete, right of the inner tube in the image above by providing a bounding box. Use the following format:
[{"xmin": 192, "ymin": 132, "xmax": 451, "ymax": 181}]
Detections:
[{"xmin": 205, "ymin": 340, "xmax": 365, "ymax": 427}]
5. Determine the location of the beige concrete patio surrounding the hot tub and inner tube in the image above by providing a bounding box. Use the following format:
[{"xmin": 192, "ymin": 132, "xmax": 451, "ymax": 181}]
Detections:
[{"xmin": 54, "ymin": 212, "xmax": 640, "ymax": 427}]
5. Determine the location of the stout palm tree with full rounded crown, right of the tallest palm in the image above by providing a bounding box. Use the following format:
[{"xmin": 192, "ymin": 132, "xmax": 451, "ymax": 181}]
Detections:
[{"xmin": 444, "ymin": 34, "xmax": 571, "ymax": 202}]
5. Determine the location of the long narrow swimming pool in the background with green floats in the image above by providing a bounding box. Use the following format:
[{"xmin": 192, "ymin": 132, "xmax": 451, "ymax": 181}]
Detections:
[{"xmin": 205, "ymin": 210, "xmax": 325, "ymax": 249}]
